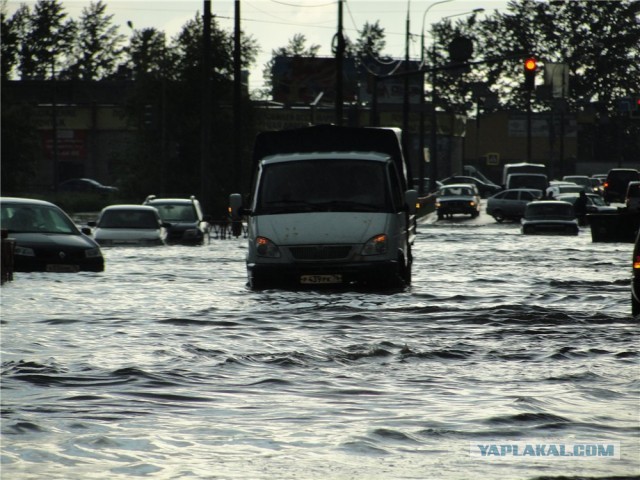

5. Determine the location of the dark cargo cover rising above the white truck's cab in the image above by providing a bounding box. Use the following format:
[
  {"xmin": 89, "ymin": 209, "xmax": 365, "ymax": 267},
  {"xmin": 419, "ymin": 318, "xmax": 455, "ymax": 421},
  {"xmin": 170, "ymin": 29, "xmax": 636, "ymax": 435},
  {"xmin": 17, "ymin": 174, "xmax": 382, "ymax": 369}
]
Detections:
[{"xmin": 253, "ymin": 125, "xmax": 412, "ymax": 190}]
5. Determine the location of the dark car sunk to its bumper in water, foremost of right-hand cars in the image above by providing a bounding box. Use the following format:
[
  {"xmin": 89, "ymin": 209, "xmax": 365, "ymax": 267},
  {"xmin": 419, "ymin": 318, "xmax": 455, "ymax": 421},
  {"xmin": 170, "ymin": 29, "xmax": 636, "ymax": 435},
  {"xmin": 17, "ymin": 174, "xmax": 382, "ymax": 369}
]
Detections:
[{"xmin": 520, "ymin": 200, "xmax": 580, "ymax": 235}]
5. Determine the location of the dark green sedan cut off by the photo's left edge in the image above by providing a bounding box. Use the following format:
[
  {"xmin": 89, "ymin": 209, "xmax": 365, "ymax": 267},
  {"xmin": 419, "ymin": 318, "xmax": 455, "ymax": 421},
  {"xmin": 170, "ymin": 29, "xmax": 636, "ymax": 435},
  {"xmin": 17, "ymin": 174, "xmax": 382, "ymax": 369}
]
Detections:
[{"xmin": 0, "ymin": 197, "xmax": 104, "ymax": 272}]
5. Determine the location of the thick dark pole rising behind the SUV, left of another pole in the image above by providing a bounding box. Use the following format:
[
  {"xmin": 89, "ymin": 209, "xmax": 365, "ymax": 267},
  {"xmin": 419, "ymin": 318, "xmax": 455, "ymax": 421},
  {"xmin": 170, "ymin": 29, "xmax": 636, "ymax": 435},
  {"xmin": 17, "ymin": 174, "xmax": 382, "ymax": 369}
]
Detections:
[{"xmin": 200, "ymin": 0, "xmax": 211, "ymax": 210}]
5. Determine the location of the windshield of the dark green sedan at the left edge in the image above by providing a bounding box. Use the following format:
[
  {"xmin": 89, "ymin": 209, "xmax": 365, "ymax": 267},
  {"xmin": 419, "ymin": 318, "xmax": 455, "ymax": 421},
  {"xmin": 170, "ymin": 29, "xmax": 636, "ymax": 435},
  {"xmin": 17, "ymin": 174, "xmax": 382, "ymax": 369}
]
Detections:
[{"xmin": 0, "ymin": 203, "xmax": 79, "ymax": 235}]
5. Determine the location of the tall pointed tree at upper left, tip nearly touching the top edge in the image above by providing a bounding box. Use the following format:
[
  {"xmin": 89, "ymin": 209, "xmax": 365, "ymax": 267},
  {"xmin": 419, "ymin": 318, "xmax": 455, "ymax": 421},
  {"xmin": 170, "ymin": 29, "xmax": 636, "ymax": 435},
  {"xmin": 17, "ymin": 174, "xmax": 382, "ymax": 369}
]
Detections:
[{"xmin": 66, "ymin": 0, "xmax": 125, "ymax": 80}]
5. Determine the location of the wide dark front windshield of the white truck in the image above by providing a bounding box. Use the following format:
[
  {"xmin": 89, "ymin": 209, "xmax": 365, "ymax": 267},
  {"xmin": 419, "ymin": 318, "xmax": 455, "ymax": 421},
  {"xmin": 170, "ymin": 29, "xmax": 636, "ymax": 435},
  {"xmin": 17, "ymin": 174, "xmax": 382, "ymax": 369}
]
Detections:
[{"xmin": 255, "ymin": 159, "xmax": 393, "ymax": 215}]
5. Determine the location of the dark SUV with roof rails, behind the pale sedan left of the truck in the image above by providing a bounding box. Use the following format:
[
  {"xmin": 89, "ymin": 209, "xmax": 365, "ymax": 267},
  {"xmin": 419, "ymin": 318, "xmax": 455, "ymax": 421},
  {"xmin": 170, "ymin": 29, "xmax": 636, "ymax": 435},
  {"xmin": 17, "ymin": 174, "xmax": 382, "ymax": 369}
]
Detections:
[{"xmin": 144, "ymin": 195, "xmax": 211, "ymax": 245}]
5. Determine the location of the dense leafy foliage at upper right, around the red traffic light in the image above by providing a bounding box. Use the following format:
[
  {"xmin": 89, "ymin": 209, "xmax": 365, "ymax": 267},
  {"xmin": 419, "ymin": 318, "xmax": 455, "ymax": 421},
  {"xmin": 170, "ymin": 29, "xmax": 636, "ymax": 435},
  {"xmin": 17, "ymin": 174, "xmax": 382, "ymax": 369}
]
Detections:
[{"xmin": 448, "ymin": 0, "xmax": 640, "ymax": 111}]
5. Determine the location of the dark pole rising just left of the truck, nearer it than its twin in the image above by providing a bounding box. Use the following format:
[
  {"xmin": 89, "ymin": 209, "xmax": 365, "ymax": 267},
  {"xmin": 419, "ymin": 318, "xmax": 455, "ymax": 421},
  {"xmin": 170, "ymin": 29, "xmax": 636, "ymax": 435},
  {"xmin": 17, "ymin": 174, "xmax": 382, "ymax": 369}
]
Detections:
[{"xmin": 233, "ymin": 0, "xmax": 242, "ymax": 192}]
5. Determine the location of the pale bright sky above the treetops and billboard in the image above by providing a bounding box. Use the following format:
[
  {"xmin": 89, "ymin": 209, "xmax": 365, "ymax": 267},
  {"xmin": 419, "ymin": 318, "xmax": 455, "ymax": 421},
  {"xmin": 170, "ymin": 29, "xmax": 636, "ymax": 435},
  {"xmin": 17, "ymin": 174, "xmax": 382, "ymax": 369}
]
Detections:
[{"xmin": 2, "ymin": 0, "xmax": 508, "ymax": 91}]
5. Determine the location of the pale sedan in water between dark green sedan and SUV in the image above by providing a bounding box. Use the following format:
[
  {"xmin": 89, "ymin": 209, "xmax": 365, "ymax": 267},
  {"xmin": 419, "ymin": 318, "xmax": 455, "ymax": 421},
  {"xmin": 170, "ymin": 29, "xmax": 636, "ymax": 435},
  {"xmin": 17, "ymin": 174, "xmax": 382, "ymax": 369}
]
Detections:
[{"xmin": 88, "ymin": 205, "xmax": 170, "ymax": 246}]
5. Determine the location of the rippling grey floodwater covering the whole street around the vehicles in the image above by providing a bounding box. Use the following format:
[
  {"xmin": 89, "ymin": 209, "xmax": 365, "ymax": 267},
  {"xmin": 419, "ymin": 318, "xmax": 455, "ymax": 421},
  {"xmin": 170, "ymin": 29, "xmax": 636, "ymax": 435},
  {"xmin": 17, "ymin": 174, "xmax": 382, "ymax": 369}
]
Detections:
[{"xmin": 1, "ymin": 220, "xmax": 640, "ymax": 480}]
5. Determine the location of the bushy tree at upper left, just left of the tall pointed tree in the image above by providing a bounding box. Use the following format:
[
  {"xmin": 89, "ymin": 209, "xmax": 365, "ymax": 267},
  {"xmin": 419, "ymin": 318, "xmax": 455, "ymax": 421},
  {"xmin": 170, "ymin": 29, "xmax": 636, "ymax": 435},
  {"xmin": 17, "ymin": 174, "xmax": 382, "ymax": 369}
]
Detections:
[{"xmin": 16, "ymin": 0, "xmax": 75, "ymax": 80}]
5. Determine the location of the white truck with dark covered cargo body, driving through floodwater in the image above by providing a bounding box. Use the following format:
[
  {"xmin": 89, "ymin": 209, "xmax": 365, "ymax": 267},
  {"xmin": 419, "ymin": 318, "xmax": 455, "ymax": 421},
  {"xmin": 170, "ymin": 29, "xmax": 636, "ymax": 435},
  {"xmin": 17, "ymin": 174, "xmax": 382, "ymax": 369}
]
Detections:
[{"xmin": 230, "ymin": 125, "xmax": 418, "ymax": 289}]
